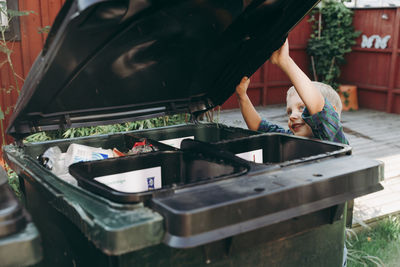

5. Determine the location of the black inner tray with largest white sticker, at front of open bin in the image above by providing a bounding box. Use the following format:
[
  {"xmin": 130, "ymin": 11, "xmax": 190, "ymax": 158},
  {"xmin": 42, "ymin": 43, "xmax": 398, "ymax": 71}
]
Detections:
[{"xmin": 69, "ymin": 151, "xmax": 250, "ymax": 203}]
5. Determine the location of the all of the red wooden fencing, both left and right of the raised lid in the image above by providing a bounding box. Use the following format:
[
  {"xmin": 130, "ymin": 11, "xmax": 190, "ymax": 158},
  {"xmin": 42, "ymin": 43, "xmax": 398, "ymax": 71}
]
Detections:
[{"xmin": 0, "ymin": 3, "xmax": 400, "ymax": 160}]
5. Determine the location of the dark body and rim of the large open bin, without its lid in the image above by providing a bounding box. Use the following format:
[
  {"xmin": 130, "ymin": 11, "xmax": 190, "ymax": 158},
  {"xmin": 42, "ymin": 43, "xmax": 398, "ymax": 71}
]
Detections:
[{"xmin": 4, "ymin": 134, "xmax": 382, "ymax": 266}]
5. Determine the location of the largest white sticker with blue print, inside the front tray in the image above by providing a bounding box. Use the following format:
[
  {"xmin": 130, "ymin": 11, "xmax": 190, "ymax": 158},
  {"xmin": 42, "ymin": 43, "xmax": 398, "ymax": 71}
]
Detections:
[{"xmin": 94, "ymin": 167, "xmax": 161, "ymax": 193}]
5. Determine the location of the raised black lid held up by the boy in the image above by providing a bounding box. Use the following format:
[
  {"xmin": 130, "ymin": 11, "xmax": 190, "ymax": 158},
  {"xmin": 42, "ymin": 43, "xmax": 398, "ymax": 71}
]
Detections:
[{"xmin": 7, "ymin": 0, "xmax": 318, "ymax": 139}]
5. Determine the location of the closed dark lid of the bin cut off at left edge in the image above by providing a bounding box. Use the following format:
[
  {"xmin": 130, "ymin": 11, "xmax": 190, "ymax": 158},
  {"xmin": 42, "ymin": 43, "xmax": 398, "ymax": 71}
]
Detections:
[{"xmin": 0, "ymin": 169, "xmax": 27, "ymax": 238}]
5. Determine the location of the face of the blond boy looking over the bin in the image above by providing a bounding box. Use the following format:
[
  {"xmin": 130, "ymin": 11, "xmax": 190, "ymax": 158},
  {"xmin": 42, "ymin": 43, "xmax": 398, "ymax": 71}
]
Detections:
[{"xmin": 286, "ymin": 93, "xmax": 313, "ymax": 137}]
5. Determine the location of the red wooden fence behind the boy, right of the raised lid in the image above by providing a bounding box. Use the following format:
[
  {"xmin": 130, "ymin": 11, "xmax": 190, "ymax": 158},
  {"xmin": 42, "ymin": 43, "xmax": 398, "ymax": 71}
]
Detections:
[{"xmin": 223, "ymin": 8, "xmax": 400, "ymax": 114}]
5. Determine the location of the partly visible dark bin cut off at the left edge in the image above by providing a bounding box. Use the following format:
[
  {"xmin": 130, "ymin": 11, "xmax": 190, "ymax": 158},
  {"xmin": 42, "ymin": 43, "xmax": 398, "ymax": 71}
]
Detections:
[{"xmin": 0, "ymin": 167, "xmax": 42, "ymax": 267}]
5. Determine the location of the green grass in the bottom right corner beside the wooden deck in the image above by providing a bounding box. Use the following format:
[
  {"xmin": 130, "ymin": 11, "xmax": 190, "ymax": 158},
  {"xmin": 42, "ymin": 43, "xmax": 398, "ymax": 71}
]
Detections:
[{"xmin": 347, "ymin": 216, "xmax": 400, "ymax": 267}]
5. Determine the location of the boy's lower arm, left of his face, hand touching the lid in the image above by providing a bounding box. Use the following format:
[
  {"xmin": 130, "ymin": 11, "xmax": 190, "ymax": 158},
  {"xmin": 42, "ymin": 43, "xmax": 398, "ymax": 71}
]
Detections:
[{"xmin": 236, "ymin": 77, "xmax": 261, "ymax": 131}]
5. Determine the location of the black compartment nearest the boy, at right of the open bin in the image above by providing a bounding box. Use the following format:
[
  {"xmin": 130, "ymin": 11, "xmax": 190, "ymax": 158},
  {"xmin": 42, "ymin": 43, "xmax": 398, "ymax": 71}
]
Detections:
[{"xmin": 216, "ymin": 134, "xmax": 351, "ymax": 164}]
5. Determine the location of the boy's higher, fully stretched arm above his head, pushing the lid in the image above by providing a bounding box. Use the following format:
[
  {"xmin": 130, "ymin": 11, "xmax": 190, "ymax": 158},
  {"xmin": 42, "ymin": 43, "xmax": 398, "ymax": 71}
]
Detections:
[{"xmin": 270, "ymin": 39, "xmax": 325, "ymax": 115}]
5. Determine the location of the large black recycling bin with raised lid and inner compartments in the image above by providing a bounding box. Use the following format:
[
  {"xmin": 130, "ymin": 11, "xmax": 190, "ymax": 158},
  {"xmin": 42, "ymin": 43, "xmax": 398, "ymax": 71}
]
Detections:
[{"xmin": 4, "ymin": 0, "xmax": 383, "ymax": 267}]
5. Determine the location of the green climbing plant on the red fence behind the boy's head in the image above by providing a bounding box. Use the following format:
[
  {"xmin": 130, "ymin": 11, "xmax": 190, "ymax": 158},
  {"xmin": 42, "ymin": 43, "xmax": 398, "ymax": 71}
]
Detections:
[{"xmin": 307, "ymin": 0, "xmax": 361, "ymax": 90}]
